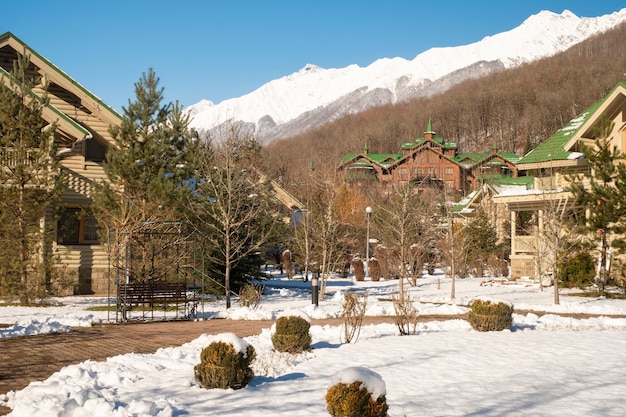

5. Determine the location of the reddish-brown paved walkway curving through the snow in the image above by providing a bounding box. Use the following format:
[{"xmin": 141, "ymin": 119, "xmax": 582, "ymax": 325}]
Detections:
[{"xmin": 0, "ymin": 317, "xmax": 412, "ymax": 415}]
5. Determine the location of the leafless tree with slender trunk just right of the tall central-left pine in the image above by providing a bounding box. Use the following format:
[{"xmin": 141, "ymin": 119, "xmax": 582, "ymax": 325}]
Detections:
[{"xmin": 189, "ymin": 127, "xmax": 281, "ymax": 308}]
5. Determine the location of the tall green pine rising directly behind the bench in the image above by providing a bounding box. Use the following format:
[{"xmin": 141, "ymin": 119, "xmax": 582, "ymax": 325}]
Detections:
[{"xmin": 94, "ymin": 69, "xmax": 198, "ymax": 281}]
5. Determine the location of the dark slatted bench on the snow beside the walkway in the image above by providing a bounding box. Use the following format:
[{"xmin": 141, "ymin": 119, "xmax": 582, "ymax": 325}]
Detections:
[{"xmin": 117, "ymin": 281, "xmax": 198, "ymax": 321}]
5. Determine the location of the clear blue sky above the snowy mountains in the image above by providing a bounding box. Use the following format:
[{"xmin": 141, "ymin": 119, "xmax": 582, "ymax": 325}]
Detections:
[{"xmin": 0, "ymin": 0, "xmax": 626, "ymax": 111}]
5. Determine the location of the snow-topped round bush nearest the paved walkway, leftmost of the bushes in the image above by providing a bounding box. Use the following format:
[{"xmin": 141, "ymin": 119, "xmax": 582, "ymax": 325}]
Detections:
[{"xmin": 194, "ymin": 333, "xmax": 256, "ymax": 389}]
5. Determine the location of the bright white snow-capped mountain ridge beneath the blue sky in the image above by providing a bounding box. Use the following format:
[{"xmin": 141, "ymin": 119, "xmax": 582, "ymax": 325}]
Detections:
[{"xmin": 187, "ymin": 8, "xmax": 626, "ymax": 143}]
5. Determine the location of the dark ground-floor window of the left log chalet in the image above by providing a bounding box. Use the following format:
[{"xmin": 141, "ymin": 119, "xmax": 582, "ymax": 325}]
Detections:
[{"xmin": 57, "ymin": 208, "xmax": 99, "ymax": 245}]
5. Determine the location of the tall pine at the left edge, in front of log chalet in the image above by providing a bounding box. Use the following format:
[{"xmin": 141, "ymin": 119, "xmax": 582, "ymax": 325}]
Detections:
[{"xmin": 0, "ymin": 54, "xmax": 63, "ymax": 304}]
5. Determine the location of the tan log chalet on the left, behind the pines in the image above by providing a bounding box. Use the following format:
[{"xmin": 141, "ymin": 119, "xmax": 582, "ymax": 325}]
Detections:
[{"xmin": 0, "ymin": 33, "xmax": 122, "ymax": 294}]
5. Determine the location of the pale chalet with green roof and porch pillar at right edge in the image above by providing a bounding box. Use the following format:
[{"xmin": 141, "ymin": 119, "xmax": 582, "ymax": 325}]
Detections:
[{"xmin": 493, "ymin": 82, "xmax": 626, "ymax": 279}]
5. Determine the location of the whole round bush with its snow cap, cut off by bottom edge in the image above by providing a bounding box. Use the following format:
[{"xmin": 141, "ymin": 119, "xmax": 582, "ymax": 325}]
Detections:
[{"xmin": 326, "ymin": 367, "xmax": 389, "ymax": 417}]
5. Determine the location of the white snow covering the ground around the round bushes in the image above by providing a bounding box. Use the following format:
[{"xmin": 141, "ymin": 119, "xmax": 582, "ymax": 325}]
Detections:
[{"xmin": 0, "ymin": 275, "xmax": 626, "ymax": 417}]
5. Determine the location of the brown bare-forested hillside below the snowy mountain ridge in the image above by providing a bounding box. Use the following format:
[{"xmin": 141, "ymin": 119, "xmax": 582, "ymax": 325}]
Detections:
[{"xmin": 264, "ymin": 20, "xmax": 626, "ymax": 195}]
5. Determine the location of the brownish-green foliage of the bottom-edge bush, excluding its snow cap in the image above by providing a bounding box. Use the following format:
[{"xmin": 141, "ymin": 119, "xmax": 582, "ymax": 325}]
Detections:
[{"xmin": 326, "ymin": 381, "xmax": 389, "ymax": 417}]
